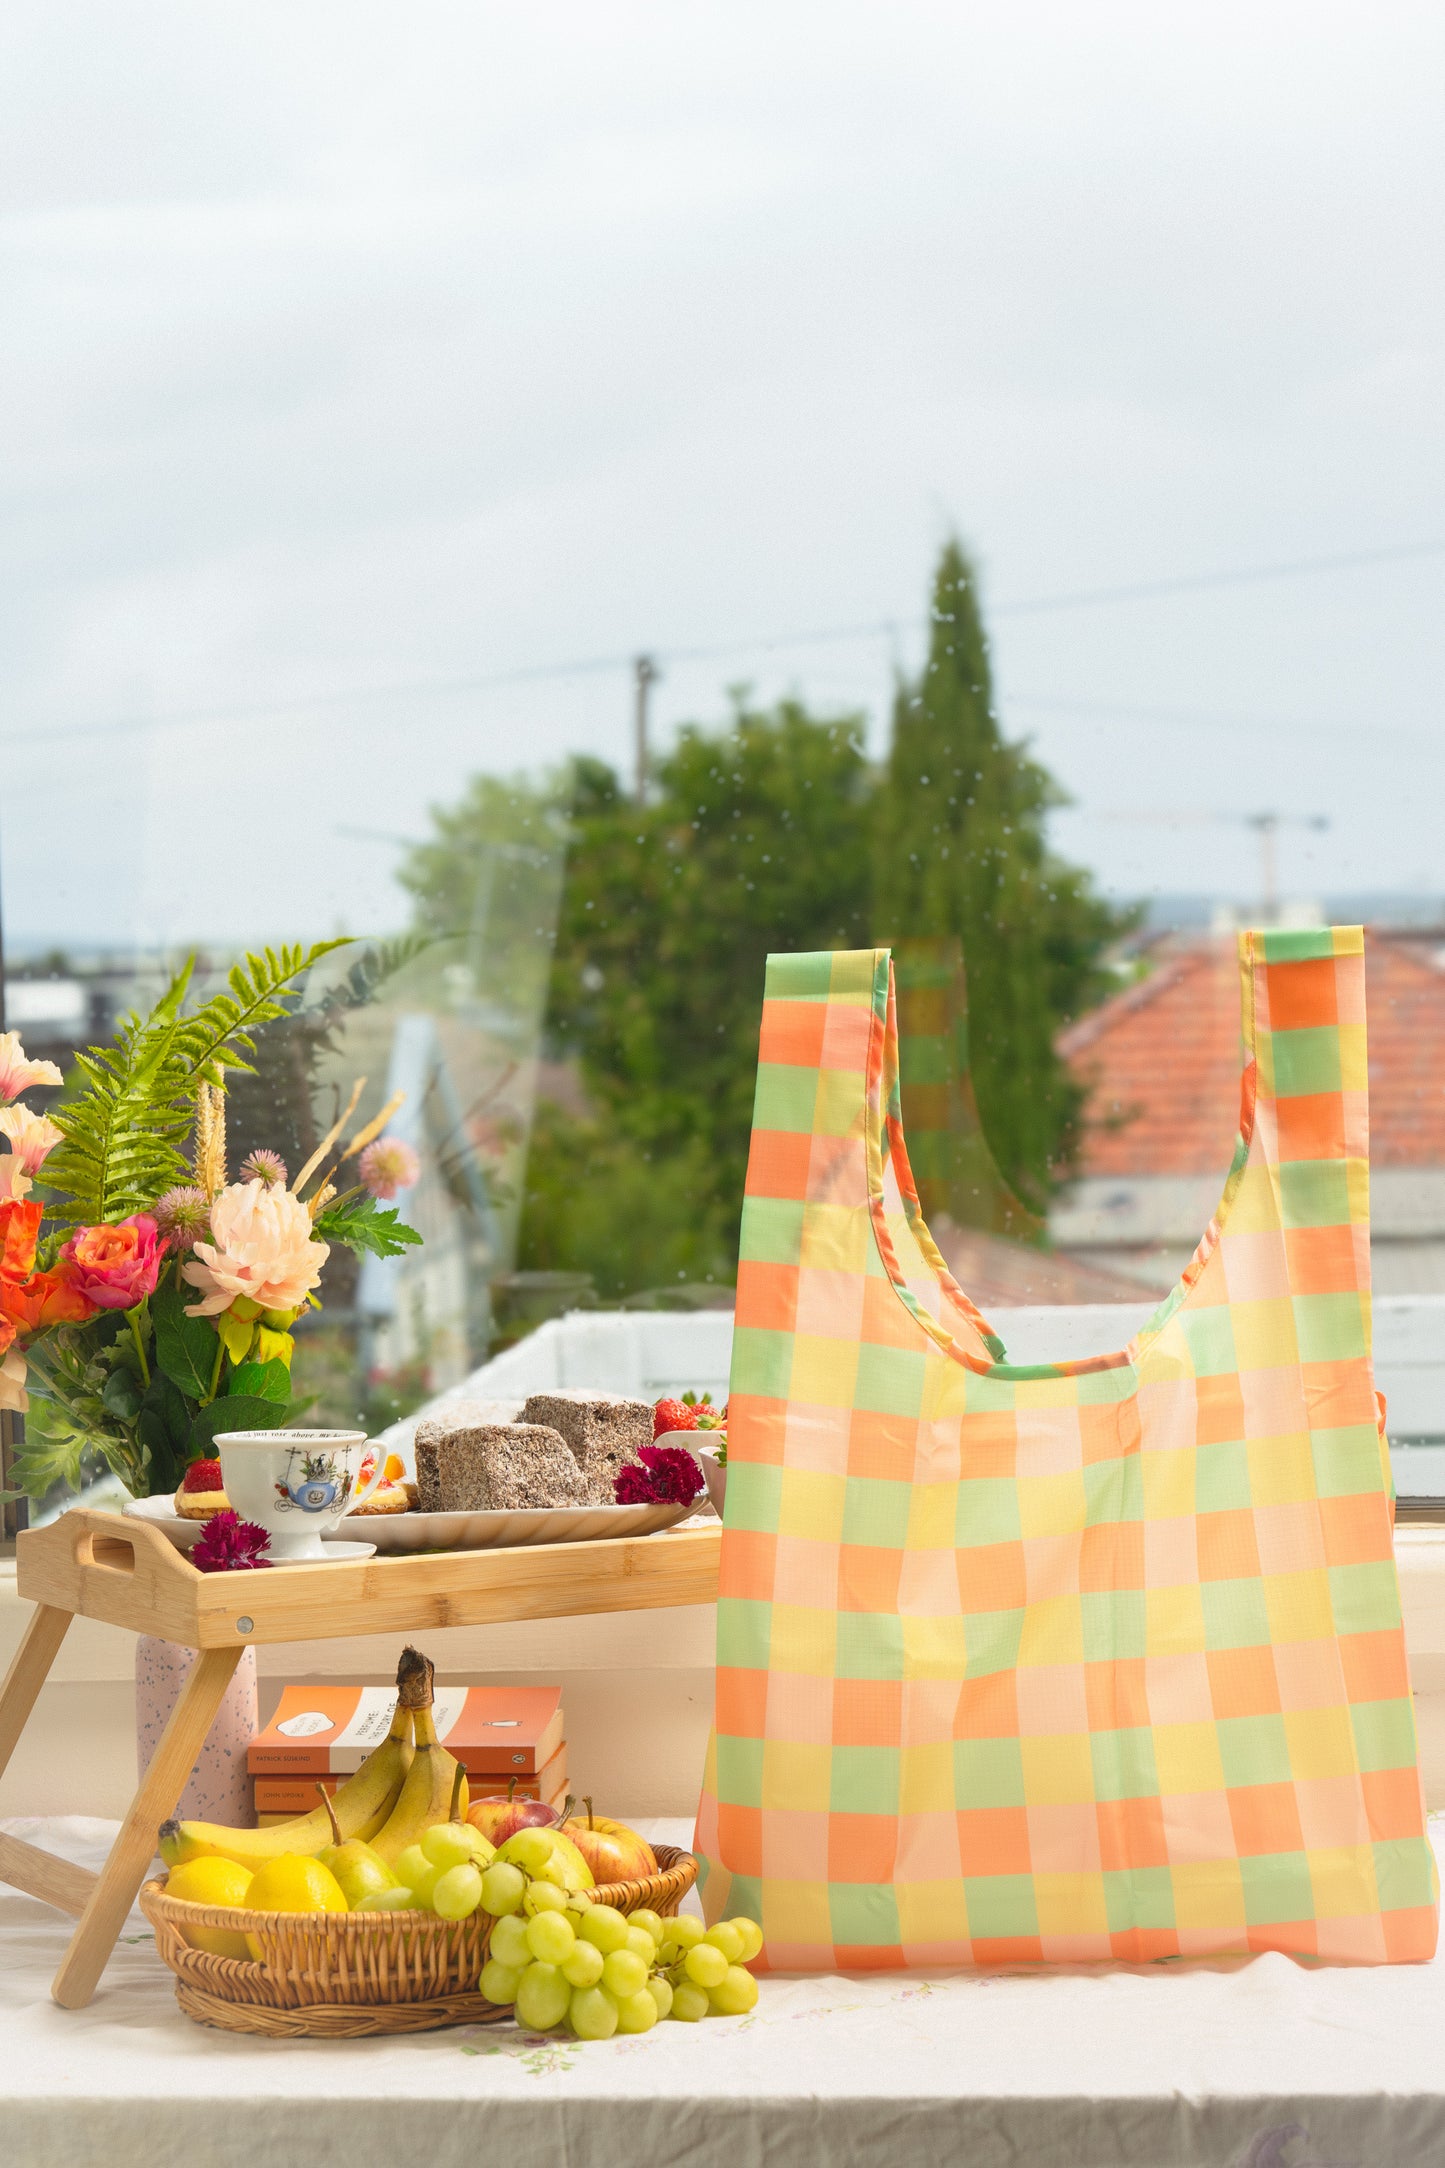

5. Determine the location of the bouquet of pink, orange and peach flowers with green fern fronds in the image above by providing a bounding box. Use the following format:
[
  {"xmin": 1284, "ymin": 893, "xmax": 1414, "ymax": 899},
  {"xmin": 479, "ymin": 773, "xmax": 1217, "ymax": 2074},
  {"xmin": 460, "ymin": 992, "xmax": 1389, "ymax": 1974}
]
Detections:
[{"xmin": 0, "ymin": 941, "xmax": 420, "ymax": 1498}]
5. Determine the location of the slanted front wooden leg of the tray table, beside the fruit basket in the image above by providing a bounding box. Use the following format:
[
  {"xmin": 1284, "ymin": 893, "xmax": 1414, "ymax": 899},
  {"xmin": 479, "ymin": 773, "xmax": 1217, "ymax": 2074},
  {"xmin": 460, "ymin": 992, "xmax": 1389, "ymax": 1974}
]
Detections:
[{"xmin": 50, "ymin": 1648, "xmax": 240, "ymax": 2010}]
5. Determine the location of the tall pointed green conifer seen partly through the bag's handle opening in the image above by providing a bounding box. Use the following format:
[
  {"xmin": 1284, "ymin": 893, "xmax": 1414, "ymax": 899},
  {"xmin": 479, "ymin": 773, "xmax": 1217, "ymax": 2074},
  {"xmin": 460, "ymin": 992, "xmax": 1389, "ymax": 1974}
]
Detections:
[{"xmin": 873, "ymin": 542, "xmax": 1129, "ymax": 1203}]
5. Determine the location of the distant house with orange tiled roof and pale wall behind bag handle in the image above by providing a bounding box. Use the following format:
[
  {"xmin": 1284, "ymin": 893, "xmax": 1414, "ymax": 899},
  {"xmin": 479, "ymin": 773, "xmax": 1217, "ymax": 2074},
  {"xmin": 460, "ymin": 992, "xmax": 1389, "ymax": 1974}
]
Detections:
[{"xmin": 1049, "ymin": 930, "xmax": 1445, "ymax": 1294}]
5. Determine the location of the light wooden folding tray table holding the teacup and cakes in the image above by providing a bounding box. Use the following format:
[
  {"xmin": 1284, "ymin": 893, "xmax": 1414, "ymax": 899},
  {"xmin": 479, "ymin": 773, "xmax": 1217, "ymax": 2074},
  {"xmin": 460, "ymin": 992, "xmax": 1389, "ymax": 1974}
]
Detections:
[{"xmin": 0, "ymin": 1507, "xmax": 721, "ymax": 2010}]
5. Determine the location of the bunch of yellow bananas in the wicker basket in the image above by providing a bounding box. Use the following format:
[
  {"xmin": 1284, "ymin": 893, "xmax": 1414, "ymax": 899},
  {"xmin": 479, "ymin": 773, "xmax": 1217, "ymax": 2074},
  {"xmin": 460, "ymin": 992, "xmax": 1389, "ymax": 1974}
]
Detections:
[{"xmin": 160, "ymin": 1648, "xmax": 466, "ymax": 1869}]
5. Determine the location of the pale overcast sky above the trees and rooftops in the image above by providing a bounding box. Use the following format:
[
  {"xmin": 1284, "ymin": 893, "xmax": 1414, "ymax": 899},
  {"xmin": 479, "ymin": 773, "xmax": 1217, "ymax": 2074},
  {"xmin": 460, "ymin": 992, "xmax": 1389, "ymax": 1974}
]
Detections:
[{"xmin": 0, "ymin": 0, "xmax": 1445, "ymax": 945}]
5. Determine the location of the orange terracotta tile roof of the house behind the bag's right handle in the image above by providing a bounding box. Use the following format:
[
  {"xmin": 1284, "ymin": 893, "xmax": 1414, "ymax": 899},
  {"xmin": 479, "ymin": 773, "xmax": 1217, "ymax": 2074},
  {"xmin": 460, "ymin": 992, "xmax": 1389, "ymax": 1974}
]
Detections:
[{"xmin": 1059, "ymin": 932, "xmax": 1445, "ymax": 1177}]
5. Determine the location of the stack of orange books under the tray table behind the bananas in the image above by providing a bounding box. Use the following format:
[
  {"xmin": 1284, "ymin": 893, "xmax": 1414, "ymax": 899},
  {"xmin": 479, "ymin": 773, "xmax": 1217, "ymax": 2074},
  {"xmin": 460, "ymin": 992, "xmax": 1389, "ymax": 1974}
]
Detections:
[{"xmin": 247, "ymin": 1687, "xmax": 568, "ymax": 1828}]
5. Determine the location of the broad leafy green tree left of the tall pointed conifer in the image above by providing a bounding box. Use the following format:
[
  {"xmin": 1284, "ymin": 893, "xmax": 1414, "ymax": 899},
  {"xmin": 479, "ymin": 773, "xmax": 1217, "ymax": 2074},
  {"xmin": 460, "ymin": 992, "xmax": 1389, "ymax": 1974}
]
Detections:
[{"xmin": 520, "ymin": 700, "xmax": 871, "ymax": 1294}]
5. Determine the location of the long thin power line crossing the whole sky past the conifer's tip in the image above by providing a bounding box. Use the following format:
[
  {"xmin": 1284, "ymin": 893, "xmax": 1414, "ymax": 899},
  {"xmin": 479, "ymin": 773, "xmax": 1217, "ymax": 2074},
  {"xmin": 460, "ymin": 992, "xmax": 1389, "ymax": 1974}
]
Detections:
[{"xmin": 0, "ymin": 542, "xmax": 1445, "ymax": 746}]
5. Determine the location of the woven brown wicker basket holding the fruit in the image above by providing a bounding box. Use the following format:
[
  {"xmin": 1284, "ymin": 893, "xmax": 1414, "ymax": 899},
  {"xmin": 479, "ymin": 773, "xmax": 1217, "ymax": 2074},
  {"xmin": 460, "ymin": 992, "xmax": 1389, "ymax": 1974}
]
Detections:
[{"xmin": 141, "ymin": 1845, "xmax": 698, "ymax": 2040}]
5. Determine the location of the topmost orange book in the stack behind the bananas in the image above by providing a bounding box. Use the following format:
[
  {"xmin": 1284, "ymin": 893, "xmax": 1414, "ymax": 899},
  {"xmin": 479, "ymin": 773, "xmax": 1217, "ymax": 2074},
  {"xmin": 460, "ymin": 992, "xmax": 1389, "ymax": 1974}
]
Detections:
[{"xmin": 247, "ymin": 1687, "xmax": 563, "ymax": 1782}]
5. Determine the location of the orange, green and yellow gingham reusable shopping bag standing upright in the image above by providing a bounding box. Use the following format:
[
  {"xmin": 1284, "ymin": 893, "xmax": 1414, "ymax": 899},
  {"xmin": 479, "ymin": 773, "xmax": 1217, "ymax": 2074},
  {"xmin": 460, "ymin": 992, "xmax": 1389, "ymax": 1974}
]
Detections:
[{"xmin": 698, "ymin": 928, "xmax": 1439, "ymax": 1971}]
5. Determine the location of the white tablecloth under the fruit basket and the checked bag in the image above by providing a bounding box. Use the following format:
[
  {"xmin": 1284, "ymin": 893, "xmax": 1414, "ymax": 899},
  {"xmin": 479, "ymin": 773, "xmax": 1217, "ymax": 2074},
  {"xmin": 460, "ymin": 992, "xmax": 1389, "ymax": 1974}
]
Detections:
[{"xmin": 0, "ymin": 1819, "xmax": 1445, "ymax": 2168}]
